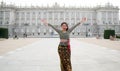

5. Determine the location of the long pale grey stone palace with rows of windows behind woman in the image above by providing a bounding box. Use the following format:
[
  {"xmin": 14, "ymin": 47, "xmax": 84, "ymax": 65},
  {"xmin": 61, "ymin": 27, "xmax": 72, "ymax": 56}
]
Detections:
[{"xmin": 0, "ymin": 2, "xmax": 120, "ymax": 37}]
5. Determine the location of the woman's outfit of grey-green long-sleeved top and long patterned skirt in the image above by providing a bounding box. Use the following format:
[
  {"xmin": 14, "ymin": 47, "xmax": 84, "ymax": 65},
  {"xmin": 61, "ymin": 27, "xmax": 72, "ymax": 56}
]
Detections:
[{"xmin": 48, "ymin": 23, "xmax": 80, "ymax": 71}]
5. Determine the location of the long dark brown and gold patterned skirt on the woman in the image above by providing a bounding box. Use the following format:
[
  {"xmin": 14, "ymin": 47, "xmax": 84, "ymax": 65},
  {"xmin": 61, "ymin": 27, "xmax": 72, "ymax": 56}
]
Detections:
[{"xmin": 58, "ymin": 45, "xmax": 72, "ymax": 71}]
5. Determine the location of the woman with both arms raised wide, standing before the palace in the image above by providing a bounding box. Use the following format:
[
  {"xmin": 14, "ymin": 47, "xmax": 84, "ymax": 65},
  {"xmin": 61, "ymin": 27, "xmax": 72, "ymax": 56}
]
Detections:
[{"xmin": 42, "ymin": 18, "xmax": 86, "ymax": 71}]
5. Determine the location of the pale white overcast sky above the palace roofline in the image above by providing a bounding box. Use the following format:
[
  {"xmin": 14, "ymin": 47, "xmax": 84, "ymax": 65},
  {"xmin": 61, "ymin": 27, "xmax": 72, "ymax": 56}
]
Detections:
[{"xmin": 0, "ymin": 0, "xmax": 120, "ymax": 19}]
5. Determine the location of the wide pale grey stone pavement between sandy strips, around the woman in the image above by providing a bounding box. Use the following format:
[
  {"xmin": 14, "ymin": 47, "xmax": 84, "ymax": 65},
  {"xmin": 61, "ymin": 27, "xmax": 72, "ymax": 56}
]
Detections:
[{"xmin": 0, "ymin": 38, "xmax": 120, "ymax": 71}]
